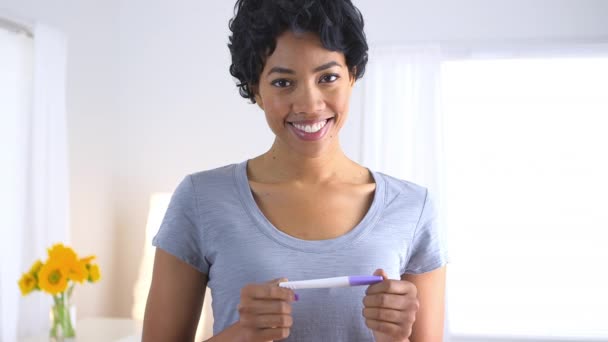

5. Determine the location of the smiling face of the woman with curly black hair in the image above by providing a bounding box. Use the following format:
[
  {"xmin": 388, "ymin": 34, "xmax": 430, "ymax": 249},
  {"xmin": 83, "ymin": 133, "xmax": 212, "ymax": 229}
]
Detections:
[{"xmin": 256, "ymin": 31, "xmax": 355, "ymax": 157}]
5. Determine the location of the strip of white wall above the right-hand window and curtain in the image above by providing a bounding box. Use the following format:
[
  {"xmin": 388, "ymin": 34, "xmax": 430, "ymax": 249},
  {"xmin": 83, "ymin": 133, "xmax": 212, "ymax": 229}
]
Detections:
[{"xmin": 354, "ymin": 0, "xmax": 608, "ymax": 45}]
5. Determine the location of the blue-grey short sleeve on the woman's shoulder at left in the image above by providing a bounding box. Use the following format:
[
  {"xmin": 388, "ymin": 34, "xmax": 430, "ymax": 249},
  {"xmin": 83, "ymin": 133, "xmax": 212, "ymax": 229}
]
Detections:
[{"xmin": 152, "ymin": 176, "xmax": 209, "ymax": 274}]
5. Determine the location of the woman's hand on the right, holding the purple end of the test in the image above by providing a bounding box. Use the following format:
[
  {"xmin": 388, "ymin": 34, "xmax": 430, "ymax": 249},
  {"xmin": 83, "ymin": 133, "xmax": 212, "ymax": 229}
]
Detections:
[{"xmin": 363, "ymin": 269, "xmax": 419, "ymax": 342}]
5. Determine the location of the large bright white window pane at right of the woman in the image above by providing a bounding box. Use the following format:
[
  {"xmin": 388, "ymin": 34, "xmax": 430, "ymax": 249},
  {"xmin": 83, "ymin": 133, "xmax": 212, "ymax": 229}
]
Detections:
[{"xmin": 442, "ymin": 58, "xmax": 608, "ymax": 340}]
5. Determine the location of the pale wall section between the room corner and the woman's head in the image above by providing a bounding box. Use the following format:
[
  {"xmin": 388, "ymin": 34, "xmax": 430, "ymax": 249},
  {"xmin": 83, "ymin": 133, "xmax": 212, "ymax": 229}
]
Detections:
[{"xmin": 116, "ymin": 0, "xmax": 272, "ymax": 315}]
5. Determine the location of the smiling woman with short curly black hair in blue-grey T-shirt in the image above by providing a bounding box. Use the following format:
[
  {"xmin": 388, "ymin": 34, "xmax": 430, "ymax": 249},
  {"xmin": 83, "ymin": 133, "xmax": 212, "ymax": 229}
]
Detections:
[{"xmin": 143, "ymin": 0, "xmax": 446, "ymax": 342}]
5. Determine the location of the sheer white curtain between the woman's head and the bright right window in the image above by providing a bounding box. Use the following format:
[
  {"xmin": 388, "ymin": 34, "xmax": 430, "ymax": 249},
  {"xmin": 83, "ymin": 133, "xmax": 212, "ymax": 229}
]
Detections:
[{"xmin": 361, "ymin": 45, "xmax": 448, "ymax": 340}]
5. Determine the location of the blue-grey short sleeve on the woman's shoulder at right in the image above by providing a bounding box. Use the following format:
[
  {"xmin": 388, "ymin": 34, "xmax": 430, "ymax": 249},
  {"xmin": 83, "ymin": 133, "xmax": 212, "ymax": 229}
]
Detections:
[{"xmin": 402, "ymin": 190, "xmax": 447, "ymax": 274}]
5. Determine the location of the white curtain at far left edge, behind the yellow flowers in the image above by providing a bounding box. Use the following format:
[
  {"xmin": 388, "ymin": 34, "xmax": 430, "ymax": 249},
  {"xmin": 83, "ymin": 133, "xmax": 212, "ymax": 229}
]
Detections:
[{"xmin": 0, "ymin": 25, "xmax": 69, "ymax": 341}]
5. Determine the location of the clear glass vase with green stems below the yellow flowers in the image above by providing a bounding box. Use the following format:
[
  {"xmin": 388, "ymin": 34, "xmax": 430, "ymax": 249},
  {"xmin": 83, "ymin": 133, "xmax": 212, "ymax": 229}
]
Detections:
[{"xmin": 49, "ymin": 292, "xmax": 76, "ymax": 342}]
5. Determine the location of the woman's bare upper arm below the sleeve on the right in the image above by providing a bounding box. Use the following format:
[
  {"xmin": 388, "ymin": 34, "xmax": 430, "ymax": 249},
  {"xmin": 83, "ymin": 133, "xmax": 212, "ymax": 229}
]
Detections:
[{"xmin": 401, "ymin": 266, "xmax": 446, "ymax": 342}]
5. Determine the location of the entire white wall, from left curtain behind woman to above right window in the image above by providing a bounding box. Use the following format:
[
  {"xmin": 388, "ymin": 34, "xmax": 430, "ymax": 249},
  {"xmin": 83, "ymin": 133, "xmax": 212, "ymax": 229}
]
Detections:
[{"xmin": 0, "ymin": 0, "xmax": 608, "ymax": 328}]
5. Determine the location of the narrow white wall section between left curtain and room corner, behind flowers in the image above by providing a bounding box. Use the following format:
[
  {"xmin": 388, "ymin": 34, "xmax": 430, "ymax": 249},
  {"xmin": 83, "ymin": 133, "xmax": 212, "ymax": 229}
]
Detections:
[{"xmin": 0, "ymin": 0, "xmax": 119, "ymax": 317}]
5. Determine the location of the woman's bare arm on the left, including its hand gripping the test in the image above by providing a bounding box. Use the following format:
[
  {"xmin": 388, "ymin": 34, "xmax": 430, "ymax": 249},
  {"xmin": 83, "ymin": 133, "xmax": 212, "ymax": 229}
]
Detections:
[{"xmin": 142, "ymin": 248, "xmax": 294, "ymax": 342}]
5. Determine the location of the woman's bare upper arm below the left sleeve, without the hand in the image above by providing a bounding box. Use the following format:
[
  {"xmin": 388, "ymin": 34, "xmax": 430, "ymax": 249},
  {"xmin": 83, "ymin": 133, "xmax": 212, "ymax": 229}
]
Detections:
[{"xmin": 142, "ymin": 248, "xmax": 207, "ymax": 342}]
